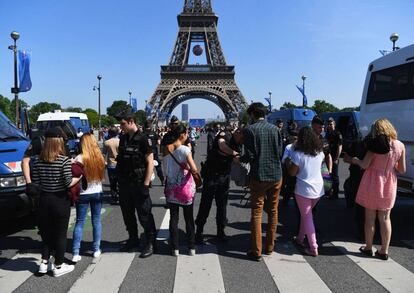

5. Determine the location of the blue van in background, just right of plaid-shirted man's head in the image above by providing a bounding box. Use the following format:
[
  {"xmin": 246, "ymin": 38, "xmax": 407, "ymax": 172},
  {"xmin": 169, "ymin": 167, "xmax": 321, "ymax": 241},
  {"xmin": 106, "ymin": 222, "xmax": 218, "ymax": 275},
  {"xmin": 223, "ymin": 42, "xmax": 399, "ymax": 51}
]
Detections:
[{"xmin": 267, "ymin": 108, "xmax": 316, "ymax": 129}]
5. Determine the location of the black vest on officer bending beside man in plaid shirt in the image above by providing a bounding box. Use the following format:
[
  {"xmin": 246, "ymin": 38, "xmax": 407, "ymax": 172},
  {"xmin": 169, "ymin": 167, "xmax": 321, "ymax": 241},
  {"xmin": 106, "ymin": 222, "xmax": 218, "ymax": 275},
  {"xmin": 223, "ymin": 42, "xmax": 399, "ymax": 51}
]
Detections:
[{"xmin": 207, "ymin": 131, "xmax": 233, "ymax": 174}]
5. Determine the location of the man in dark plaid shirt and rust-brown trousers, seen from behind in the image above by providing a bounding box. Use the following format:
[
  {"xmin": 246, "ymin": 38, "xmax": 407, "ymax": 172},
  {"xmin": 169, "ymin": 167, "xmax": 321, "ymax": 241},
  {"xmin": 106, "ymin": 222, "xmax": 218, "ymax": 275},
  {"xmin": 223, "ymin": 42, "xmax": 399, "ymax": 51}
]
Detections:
[{"xmin": 235, "ymin": 103, "xmax": 282, "ymax": 261}]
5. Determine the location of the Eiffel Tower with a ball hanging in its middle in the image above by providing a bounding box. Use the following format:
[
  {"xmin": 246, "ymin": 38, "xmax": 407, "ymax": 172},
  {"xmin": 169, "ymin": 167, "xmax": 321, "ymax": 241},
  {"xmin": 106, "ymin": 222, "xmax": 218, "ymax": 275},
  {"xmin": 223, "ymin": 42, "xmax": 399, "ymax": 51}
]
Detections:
[{"xmin": 146, "ymin": 0, "xmax": 248, "ymax": 124}]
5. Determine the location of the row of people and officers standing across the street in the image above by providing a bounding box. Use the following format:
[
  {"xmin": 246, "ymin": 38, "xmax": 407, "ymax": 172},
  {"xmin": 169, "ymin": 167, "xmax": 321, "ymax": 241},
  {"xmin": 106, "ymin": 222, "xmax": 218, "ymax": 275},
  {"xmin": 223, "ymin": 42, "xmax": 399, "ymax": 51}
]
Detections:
[{"xmin": 22, "ymin": 103, "xmax": 405, "ymax": 276}]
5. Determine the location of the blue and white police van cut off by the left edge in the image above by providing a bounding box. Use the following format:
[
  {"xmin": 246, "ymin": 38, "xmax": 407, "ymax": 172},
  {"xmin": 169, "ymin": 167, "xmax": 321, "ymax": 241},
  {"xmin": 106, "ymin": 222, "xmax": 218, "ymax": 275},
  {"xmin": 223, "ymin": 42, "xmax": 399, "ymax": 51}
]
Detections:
[{"xmin": 0, "ymin": 111, "xmax": 32, "ymax": 219}]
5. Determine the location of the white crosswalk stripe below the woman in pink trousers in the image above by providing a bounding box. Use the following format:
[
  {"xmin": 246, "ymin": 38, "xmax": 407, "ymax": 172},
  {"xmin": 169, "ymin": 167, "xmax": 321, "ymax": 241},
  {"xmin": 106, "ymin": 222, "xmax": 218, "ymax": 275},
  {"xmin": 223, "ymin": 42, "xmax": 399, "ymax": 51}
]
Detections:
[{"xmin": 263, "ymin": 242, "xmax": 331, "ymax": 293}]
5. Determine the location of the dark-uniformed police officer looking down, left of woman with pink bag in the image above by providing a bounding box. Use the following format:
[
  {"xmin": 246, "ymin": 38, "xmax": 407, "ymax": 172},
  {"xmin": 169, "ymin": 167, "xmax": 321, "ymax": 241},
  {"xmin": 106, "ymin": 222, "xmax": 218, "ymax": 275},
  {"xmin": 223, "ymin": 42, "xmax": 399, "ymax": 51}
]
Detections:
[{"xmin": 116, "ymin": 112, "xmax": 156, "ymax": 258}]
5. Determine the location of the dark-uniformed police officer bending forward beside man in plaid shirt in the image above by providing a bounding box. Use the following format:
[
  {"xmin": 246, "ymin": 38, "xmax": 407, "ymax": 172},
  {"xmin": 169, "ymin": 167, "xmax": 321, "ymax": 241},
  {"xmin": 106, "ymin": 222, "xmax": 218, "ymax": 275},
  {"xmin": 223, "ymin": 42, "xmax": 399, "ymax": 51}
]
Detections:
[{"xmin": 195, "ymin": 125, "xmax": 238, "ymax": 244}]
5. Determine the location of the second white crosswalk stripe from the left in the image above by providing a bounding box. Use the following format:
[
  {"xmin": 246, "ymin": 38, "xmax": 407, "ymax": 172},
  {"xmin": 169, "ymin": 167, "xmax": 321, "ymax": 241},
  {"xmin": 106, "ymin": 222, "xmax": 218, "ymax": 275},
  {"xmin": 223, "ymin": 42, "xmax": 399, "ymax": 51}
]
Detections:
[{"xmin": 69, "ymin": 253, "xmax": 135, "ymax": 293}]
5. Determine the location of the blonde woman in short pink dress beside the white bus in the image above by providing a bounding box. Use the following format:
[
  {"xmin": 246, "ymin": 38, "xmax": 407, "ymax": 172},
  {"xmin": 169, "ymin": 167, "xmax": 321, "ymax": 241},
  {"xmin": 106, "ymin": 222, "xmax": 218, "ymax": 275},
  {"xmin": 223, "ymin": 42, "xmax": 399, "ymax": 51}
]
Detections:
[{"xmin": 344, "ymin": 119, "xmax": 406, "ymax": 260}]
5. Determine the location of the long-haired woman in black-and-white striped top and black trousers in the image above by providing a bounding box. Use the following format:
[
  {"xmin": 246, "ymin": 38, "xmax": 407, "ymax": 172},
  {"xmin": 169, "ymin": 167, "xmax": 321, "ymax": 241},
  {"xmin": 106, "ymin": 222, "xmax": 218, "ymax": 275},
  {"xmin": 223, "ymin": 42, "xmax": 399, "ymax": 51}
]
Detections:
[{"xmin": 32, "ymin": 128, "xmax": 80, "ymax": 277}]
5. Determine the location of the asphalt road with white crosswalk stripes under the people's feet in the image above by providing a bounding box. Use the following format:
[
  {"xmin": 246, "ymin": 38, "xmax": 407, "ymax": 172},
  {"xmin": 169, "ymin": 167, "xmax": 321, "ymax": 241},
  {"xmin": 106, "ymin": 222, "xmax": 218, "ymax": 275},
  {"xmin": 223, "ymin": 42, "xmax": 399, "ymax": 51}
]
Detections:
[{"xmin": 0, "ymin": 133, "xmax": 414, "ymax": 293}]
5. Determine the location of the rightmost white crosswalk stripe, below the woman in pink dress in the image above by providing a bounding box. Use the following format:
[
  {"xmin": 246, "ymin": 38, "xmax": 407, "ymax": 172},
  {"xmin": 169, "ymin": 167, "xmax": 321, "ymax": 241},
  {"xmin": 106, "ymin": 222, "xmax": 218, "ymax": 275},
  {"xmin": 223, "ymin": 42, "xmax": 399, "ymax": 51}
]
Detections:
[{"xmin": 332, "ymin": 241, "xmax": 414, "ymax": 292}]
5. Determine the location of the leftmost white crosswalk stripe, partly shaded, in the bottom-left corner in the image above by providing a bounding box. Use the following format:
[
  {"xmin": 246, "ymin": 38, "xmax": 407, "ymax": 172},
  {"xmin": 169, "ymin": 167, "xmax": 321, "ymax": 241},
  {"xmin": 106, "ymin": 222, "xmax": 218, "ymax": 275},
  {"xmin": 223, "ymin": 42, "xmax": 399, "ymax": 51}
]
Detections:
[{"xmin": 0, "ymin": 253, "xmax": 41, "ymax": 292}]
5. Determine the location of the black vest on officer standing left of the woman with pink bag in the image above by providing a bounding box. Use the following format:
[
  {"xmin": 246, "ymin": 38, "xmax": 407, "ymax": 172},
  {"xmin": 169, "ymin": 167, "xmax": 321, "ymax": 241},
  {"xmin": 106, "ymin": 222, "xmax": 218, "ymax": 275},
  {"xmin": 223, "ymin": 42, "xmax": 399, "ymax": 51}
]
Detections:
[{"xmin": 116, "ymin": 132, "xmax": 147, "ymax": 182}]
